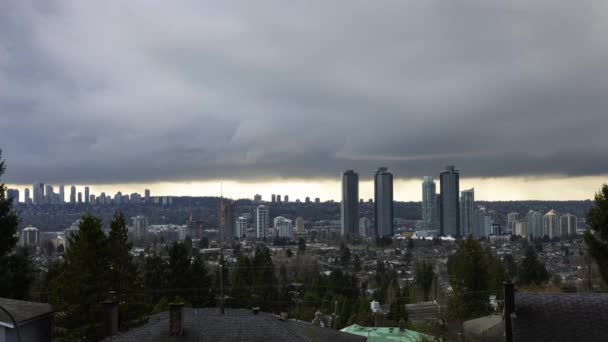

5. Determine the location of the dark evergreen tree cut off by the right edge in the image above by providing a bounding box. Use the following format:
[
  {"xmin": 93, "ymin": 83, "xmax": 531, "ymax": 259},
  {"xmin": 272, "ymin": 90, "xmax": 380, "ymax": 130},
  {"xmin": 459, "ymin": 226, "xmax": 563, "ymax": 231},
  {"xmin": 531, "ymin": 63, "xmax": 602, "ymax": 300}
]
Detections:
[{"xmin": 584, "ymin": 184, "xmax": 608, "ymax": 284}]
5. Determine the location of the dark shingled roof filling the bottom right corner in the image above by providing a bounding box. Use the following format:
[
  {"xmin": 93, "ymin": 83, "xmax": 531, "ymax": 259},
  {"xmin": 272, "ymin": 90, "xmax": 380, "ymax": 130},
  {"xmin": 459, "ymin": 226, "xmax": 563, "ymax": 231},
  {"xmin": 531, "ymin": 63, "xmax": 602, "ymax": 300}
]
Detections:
[{"xmin": 512, "ymin": 293, "xmax": 608, "ymax": 342}]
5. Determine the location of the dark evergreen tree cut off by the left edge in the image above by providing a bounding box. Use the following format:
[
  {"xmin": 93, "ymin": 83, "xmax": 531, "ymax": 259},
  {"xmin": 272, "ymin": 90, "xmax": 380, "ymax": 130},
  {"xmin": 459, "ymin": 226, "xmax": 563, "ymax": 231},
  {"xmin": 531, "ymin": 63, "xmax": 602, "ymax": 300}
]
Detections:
[{"xmin": 0, "ymin": 150, "xmax": 35, "ymax": 299}]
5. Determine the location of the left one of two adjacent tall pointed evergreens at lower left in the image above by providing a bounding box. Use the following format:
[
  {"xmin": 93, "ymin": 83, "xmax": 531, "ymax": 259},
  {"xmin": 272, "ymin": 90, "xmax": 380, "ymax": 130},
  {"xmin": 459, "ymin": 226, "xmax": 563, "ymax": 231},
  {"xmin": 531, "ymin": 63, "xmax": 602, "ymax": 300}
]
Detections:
[{"xmin": 51, "ymin": 214, "xmax": 110, "ymax": 341}]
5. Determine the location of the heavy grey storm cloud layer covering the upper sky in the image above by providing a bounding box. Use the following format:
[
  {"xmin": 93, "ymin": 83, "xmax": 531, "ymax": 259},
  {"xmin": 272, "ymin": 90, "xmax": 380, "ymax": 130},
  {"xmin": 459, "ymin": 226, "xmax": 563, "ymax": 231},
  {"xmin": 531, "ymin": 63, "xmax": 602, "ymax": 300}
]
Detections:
[{"xmin": 0, "ymin": 0, "xmax": 608, "ymax": 183}]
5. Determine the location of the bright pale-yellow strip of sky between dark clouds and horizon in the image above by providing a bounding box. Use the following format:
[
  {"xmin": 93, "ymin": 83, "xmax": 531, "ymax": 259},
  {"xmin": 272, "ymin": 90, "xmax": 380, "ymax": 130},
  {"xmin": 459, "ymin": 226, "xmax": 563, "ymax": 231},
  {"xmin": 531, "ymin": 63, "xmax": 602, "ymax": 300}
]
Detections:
[{"xmin": 6, "ymin": 174, "xmax": 608, "ymax": 203}]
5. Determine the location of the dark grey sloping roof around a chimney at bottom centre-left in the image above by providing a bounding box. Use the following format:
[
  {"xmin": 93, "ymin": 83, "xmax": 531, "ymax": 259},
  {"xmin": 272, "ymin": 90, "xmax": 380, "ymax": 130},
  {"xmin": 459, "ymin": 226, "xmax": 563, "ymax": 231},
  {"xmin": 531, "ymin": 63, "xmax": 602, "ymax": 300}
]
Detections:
[{"xmin": 106, "ymin": 308, "xmax": 366, "ymax": 342}]
